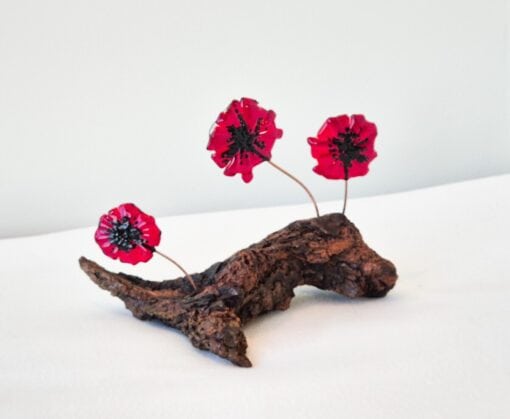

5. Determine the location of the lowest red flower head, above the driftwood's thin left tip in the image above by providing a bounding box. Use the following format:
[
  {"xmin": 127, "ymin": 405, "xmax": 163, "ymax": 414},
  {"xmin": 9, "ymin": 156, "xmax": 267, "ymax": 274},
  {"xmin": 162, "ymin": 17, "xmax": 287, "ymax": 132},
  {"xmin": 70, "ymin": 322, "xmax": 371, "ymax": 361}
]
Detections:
[{"xmin": 95, "ymin": 204, "xmax": 161, "ymax": 265}]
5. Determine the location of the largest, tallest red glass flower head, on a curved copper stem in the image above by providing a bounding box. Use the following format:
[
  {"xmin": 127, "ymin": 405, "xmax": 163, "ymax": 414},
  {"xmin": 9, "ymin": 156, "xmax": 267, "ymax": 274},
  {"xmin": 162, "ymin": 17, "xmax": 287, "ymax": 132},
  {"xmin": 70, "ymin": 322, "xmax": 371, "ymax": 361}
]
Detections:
[{"xmin": 207, "ymin": 98, "xmax": 283, "ymax": 183}]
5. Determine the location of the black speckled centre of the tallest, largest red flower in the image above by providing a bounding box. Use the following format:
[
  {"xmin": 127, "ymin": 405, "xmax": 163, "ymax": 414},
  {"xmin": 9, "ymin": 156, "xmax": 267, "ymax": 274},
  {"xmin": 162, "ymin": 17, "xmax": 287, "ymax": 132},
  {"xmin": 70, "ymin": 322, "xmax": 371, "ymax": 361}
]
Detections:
[{"xmin": 221, "ymin": 109, "xmax": 268, "ymax": 163}]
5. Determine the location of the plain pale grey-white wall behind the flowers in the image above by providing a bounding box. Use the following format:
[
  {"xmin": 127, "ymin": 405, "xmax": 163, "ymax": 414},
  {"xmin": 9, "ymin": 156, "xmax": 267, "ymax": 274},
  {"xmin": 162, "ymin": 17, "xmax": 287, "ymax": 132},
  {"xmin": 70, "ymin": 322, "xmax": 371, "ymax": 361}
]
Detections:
[{"xmin": 0, "ymin": 0, "xmax": 510, "ymax": 237}]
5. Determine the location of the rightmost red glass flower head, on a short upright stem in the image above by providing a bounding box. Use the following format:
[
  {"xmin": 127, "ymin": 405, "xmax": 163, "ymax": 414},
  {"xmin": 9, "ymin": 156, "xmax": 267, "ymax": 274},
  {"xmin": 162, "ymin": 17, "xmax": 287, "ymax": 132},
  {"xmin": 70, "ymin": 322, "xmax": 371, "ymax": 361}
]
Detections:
[{"xmin": 308, "ymin": 115, "xmax": 377, "ymax": 180}]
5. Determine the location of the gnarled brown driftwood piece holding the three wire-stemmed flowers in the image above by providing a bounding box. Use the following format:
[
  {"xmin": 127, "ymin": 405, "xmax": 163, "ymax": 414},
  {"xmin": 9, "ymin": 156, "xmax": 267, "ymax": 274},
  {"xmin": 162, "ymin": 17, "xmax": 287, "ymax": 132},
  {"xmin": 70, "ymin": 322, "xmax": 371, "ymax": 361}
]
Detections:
[{"xmin": 80, "ymin": 214, "xmax": 397, "ymax": 367}]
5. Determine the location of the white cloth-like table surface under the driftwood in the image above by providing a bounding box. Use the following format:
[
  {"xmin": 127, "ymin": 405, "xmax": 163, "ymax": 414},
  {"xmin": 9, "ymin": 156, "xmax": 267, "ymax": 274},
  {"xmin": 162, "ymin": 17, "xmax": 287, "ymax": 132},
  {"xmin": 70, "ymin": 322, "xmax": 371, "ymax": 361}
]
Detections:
[{"xmin": 0, "ymin": 175, "xmax": 510, "ymax": 419}]
